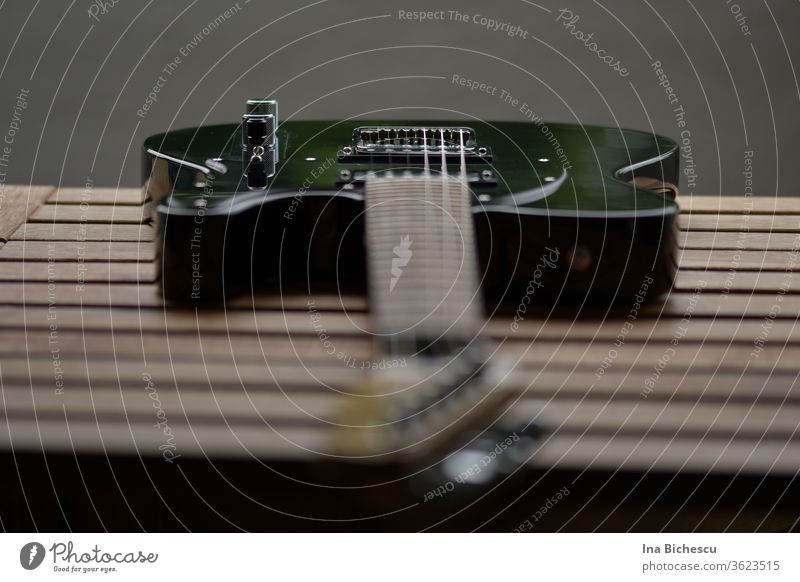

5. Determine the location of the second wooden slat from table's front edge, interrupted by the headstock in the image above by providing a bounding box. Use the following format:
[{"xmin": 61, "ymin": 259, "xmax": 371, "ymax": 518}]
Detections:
[{"xmin": 3, "ymin": 388, "xmax": 800, "ymax": 443}]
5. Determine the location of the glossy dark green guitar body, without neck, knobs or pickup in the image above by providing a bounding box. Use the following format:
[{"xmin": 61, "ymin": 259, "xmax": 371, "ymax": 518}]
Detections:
[{"xmin": 143, "ymin": 120, "xmax": 679, "ymax": 310}]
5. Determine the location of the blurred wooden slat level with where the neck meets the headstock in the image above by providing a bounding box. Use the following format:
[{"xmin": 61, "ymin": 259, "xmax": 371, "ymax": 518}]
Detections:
[{"xmin": 6, "ymin": 329, "xmax": 797, "ymax": 378}]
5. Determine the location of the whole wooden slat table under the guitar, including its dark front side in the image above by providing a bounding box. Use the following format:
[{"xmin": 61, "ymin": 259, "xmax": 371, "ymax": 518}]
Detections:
[{"xmin": 0, "ymin": 188, "xmax": 800, "ymax": 531}]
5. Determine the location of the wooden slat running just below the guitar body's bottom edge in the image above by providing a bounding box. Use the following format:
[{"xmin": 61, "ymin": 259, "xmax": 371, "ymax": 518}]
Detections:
[{"xmin": 0, "ymin": 295, "xmax": 800, "ymax": 341}]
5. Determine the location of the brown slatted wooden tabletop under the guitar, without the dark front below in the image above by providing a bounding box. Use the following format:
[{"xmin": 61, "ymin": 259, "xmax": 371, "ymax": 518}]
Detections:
[{"xmin": 0, "ymin": 188, "xmax": 800, "ymax": 475}]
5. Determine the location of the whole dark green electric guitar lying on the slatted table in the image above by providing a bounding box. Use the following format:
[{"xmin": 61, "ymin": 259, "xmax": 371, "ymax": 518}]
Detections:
[{"xmin": 143, "ymin": 100, "xmax": 679, "ymax": 460}]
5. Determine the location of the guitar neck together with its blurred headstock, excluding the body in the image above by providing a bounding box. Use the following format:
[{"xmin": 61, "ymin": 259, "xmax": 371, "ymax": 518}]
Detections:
[{"xmin": 326, "ymin": 175, "xmax": 508, "ymax": 459}]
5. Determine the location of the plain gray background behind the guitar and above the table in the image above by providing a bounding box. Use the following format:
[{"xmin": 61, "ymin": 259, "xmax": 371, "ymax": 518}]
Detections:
[{"xmin": 0, "ymin": 0, "xmax": 800, "ymax": 195}]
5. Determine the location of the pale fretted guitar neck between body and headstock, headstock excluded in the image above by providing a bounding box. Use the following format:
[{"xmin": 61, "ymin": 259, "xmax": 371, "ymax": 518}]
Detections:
[{"xmin": 365, "ymin": 175, "xmax": 483, "ymax": 355}]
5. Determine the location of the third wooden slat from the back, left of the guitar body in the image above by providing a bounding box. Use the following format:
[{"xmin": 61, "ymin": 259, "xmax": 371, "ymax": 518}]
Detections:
[{"xmin": 11, "ymin": 222, "xmax": 153, "ymax": 242}]
